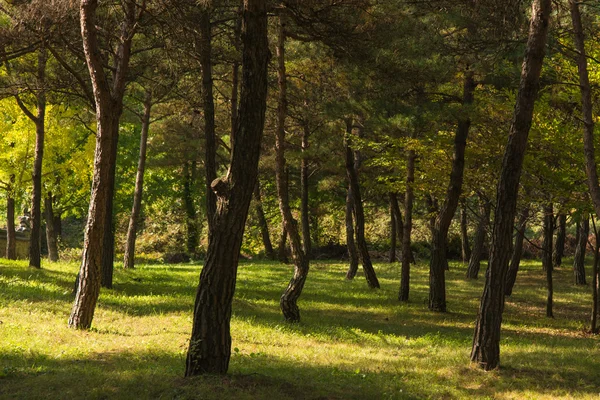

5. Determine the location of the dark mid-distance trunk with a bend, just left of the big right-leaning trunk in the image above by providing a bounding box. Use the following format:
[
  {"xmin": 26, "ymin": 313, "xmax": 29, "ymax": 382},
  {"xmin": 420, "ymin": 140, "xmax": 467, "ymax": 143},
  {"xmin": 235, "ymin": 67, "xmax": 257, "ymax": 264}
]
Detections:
[{"xmin": 429, "ymin": 71, "xmax": 476, "ymax": 312}]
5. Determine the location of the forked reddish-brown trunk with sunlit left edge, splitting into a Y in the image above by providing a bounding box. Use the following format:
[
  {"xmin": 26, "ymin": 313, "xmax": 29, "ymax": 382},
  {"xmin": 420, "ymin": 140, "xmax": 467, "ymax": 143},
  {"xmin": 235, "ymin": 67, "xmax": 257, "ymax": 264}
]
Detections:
[{"xmin": 69, "ymin": 0, "xmax": 139, "ymax": 329}]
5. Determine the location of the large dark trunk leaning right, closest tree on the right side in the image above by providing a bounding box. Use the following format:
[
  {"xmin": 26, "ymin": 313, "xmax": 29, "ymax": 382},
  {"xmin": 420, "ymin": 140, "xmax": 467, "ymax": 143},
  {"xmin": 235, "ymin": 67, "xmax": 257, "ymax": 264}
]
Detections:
[{"xmin": 471, "ymin": 0, "xmax": 552, "ymax": 370}]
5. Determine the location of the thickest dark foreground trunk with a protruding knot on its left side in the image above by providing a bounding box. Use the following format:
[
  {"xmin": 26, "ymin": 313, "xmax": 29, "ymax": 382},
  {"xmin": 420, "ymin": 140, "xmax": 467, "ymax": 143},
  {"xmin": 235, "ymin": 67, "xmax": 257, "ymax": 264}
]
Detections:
[{"xmin": 185, "ymin": 0, "xmax": 269, "ymax": 376}]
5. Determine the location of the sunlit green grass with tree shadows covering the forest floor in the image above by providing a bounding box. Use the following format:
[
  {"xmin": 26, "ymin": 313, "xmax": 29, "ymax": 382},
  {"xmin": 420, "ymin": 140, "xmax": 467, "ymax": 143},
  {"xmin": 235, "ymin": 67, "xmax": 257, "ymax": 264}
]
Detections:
[{"xmin": 0, "ymin": 260, "xmax": 600, "ymax": 400}]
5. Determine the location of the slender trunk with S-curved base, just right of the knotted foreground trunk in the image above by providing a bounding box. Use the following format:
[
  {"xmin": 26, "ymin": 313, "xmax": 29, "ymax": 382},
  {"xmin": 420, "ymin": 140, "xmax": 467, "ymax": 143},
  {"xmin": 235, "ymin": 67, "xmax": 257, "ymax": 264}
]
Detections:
[{"xmin": 275, "ymin": 17, "xmax": 309, "ymax": 322}]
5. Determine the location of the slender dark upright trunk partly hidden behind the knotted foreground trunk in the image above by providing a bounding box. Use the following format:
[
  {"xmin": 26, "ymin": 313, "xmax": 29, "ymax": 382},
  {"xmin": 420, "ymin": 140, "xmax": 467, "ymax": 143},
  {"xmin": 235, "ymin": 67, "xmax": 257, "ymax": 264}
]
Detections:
[{"xmin": 198, "ymin": 5, "xmax": 217, "ymax": 230}]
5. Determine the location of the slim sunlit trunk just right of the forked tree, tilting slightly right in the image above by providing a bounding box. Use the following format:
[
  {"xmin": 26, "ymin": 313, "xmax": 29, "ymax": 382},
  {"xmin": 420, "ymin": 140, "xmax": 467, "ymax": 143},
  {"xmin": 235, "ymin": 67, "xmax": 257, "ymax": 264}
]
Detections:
[{"xmin": 123, "ymin": 91, "xmax": 152, "ymax": 269}]
